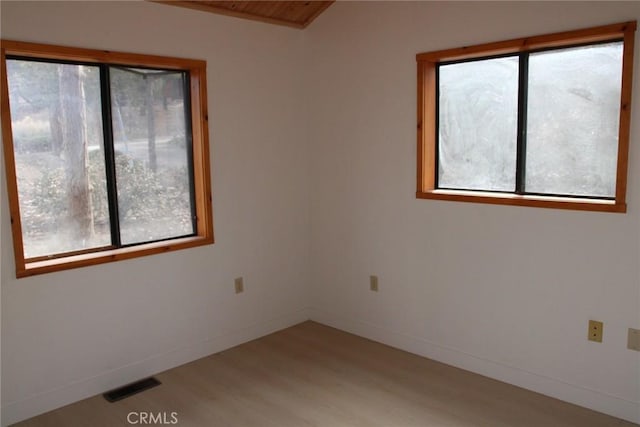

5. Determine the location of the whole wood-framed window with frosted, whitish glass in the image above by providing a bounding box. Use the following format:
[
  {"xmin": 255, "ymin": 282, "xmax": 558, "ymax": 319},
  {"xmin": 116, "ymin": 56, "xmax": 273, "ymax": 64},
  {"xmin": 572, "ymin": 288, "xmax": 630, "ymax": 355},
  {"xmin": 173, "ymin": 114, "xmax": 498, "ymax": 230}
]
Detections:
[{"xmin": 416, "ymin": 22, "xmax": 636, "ymax": 212}]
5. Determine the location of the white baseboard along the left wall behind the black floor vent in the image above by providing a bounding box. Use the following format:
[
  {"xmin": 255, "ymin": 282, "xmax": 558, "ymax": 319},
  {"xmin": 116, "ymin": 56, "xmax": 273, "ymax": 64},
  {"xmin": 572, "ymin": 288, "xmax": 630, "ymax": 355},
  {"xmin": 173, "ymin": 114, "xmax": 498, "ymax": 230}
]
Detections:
[{"xmin": 1, "ymin": 309, "xmax": 309, "ymax": 426}]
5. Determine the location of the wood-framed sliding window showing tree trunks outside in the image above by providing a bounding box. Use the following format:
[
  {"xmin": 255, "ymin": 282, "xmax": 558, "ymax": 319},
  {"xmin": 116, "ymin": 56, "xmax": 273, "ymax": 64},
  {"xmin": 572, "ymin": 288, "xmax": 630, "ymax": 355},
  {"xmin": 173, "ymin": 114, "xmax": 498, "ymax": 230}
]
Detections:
[{"xmin": 1, "ymin": 40, "xmax": 213, "ymax": 277}]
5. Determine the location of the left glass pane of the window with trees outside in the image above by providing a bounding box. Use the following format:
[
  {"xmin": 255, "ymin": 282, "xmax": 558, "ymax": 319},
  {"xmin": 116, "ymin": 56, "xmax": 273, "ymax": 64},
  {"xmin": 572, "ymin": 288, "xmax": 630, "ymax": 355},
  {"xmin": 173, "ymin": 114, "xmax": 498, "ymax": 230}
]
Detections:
[{"xmin": 7, "ymin": 59, "xmax": 111, "ymax": 258}]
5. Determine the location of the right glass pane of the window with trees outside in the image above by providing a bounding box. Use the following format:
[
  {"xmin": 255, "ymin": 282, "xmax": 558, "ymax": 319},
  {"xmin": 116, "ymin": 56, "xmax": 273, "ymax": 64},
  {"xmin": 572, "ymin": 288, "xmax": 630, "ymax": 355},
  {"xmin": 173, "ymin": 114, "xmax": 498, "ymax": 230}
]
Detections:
[{"xmin": 110, "ymin": 67, "xmax": 195, "ymax": 245}]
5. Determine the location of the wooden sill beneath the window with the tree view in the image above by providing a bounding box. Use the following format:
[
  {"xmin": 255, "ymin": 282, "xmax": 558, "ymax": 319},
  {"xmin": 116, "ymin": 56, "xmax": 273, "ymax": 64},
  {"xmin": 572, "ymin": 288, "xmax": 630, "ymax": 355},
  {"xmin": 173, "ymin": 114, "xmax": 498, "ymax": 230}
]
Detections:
[{"xmin": 16, "ymin": 236, "xmax": 213, "ymax": 278}]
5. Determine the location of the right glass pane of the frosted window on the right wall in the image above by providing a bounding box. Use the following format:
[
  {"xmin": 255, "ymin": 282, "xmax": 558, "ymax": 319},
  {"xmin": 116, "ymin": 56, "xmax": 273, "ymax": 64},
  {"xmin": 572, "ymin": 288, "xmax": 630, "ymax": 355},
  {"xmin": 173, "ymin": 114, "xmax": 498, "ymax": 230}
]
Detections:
[{"xmin": 525, "ymin": 42, "xmax": 622, "ymax": 197}]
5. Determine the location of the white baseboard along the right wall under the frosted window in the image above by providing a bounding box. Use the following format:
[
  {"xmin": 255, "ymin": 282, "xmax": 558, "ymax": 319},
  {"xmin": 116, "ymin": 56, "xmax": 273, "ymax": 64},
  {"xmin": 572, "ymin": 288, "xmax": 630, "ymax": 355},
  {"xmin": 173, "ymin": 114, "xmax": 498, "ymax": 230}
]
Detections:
[{"xmin": 309, "ymin": 309, "xmax": 640, "ymax": 424}]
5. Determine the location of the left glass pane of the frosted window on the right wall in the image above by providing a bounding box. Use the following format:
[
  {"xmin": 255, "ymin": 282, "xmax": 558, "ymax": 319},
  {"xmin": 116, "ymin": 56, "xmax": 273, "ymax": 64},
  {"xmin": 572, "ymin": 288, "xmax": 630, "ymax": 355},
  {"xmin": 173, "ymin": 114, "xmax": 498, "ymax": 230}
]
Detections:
[{"xmin": 438, "ymin": 57, "xmax": 518, "ymax": 191}]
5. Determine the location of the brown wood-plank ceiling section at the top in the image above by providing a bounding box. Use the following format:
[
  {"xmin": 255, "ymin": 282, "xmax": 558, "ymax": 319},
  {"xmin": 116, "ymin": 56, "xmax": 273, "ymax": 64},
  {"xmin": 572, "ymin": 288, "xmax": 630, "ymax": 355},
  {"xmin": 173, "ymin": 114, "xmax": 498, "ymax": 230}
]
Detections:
[{"xmin": 149, "ymin": 0, "xmax": 335, "ymax": 28}]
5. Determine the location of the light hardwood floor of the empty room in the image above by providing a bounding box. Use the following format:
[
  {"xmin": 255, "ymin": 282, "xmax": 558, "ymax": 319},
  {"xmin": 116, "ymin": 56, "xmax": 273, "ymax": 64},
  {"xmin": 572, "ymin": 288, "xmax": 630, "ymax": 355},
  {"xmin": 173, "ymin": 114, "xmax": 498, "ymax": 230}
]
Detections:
[{"xmin": 12, "ymin": 322, "xmax": 636, "ymax": 427}]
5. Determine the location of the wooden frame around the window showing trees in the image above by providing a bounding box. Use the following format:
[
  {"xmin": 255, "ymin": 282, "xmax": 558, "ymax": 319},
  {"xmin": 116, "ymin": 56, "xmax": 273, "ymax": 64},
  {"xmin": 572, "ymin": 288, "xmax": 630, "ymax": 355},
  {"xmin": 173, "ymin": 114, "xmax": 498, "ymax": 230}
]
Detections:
[{"xmin": 0, "ymin": 40, "xmax": 214, "ymax": 278}]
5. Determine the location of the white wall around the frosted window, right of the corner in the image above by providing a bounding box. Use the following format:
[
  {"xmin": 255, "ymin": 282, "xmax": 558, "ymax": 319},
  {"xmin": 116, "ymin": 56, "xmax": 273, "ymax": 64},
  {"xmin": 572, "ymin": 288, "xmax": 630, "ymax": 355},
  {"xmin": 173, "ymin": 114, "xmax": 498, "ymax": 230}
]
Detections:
[{"xmin": 306, "ymin": 2, "xmax": 640, "ymax": 422}]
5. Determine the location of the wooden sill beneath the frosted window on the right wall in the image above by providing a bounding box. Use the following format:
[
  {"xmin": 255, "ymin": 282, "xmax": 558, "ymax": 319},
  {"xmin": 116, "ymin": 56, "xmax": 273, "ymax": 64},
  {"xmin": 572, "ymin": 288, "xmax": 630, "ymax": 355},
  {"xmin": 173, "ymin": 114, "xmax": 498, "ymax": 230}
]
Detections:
[{"xmin": 416, "ymin": 190, "xmax": 627, "ymax": 213}]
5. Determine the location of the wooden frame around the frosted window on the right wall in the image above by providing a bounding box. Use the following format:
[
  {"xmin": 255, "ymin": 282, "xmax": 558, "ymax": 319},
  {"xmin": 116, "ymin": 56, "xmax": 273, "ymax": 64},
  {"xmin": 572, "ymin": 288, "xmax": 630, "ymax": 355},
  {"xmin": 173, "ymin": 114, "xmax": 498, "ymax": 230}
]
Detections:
[{"xmin": 416, "ymin": 21, "xmax": 636, "ymax": 213}]
